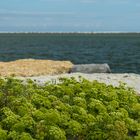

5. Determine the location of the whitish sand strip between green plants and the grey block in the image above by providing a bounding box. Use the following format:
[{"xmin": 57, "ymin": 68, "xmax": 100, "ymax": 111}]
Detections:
[{"xmin": 18, "ymin": 73, "xmax": 140, "ymax": 94}]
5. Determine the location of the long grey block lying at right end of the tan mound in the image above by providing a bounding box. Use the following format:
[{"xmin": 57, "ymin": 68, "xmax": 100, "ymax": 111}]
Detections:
[{"xmin": 70, "ymin": 64, "xmax": 111, "ymax": 73}]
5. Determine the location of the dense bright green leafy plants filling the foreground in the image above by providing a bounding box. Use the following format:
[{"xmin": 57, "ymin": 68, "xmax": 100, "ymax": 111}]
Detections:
[{"xmin": 0, "ymin": 78, "xmax": 140, "ymax": 140}]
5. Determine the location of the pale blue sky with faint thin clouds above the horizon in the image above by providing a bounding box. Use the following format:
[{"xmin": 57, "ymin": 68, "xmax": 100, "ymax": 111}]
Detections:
[{"xmin": 0, "ymin": 0, "xmax": 140, "ymax": 32}]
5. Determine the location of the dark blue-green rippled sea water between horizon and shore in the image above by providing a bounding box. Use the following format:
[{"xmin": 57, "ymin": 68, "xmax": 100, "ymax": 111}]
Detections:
[{"xmin": 0, "ymin": 33, "xmax": 140, "ymax": 74}]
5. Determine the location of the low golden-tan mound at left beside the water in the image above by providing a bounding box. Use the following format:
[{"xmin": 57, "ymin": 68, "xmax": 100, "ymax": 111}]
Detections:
[{"xmin": 0, "ymin": 59, "xmax": 73, "ymax": 77}]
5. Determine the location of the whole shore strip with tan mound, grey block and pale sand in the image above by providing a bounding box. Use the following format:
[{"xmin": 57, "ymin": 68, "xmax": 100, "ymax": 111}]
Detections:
[{"xmin": 0, "ymin": 59, "xmax": 140, "ymax": 94}]
